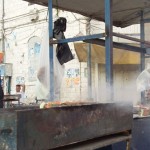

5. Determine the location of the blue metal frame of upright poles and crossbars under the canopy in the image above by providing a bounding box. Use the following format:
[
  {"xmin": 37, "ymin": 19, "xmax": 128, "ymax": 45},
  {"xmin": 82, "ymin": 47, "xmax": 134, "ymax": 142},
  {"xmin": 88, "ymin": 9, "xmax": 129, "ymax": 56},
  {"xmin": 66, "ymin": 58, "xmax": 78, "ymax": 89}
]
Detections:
[{"xmin": 48, "ymin": 0, "xmax": 150, "ymax": 101}]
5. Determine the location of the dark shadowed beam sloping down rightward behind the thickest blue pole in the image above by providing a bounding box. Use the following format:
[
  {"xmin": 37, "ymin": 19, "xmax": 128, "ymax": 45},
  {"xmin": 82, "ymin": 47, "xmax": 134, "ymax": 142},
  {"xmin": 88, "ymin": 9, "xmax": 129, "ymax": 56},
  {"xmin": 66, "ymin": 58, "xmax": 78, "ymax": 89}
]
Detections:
[{"xmin": 84, "ymin": 39, "xmax": 146, "ymax": 53}]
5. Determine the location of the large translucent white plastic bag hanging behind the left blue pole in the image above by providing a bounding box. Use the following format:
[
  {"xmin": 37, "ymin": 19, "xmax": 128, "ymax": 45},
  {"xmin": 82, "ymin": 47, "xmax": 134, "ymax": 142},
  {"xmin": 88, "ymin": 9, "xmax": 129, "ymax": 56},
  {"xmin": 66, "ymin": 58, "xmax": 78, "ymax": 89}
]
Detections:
[{"xmin": 36, "ymin": 29, "xmax": 65, "ymax": 100}]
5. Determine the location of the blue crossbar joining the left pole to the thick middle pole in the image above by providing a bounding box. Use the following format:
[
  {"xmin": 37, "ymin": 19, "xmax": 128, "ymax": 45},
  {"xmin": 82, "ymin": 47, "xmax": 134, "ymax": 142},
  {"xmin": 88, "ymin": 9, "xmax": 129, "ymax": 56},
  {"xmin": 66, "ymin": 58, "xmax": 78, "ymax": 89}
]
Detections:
[{"xmin": 50, "ymin": 33, "xmax": 105, "ymax": 44}]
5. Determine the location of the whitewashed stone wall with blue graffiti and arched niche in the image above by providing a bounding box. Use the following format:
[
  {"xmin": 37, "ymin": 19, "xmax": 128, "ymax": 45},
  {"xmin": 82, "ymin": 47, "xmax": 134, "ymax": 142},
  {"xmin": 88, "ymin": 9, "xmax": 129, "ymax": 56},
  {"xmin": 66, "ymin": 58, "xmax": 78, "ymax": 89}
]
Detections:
[{"xmin": 0, "ymin": 0, "xmax": 85, "ymax": 102}]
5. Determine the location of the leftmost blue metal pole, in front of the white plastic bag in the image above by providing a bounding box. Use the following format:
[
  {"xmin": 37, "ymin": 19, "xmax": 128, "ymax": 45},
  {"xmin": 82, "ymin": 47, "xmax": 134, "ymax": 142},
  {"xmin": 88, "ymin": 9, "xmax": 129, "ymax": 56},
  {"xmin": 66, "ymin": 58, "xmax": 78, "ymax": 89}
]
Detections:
[{"xmin": 48, "ymin": 0, "xmax": 54, "ymax": 101}]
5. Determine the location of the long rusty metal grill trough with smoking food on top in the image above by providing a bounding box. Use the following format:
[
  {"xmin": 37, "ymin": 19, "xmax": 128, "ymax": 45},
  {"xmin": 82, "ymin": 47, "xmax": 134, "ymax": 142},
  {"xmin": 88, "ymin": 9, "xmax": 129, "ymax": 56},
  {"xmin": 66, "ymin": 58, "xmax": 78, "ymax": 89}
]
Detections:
[{"xmin": 0, "ymin": 103, "xmax": 132, "ymax": 150}]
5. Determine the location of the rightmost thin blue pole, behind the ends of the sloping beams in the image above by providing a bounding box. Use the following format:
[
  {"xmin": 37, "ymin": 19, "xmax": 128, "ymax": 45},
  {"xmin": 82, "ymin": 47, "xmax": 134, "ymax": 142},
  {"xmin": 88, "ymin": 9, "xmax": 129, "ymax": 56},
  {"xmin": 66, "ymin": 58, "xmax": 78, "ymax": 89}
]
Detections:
[{"xmin": 140, "ymin": 11, "xmax": 145, "ymax": 104}]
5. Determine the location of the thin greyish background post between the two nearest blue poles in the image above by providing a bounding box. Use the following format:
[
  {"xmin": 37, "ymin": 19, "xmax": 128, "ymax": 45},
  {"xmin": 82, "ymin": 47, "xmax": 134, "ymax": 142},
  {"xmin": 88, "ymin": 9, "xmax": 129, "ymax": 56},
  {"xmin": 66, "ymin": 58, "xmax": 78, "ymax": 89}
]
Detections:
[{"xmin": 86, "ymin": 18, "xmax": 92, "ymax": 100}]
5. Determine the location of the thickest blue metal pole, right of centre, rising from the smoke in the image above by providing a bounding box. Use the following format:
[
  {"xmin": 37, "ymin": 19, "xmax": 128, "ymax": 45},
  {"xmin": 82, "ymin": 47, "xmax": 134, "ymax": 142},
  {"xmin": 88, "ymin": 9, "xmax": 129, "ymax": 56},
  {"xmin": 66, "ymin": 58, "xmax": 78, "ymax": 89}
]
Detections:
[{"xmin": 105, "ymin": 0, "xmax": 113, "ymax": 100}]
